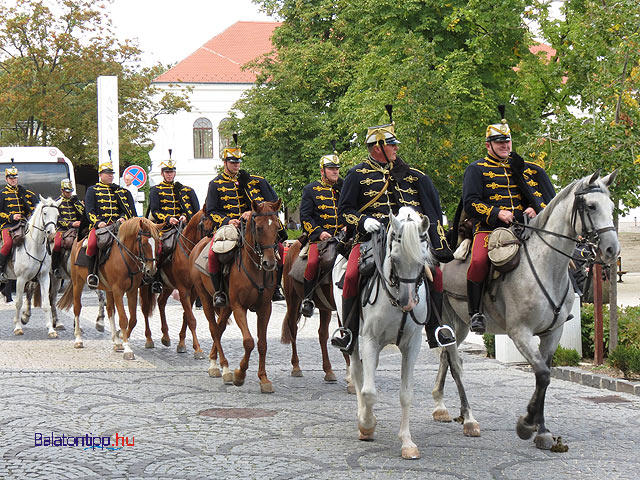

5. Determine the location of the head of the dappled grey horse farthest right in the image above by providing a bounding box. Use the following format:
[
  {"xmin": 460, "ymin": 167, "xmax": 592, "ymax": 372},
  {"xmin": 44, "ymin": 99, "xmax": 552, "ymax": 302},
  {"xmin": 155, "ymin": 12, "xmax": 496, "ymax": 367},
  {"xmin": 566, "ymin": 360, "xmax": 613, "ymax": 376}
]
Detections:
[{"xmin": 573, "ymin": 170, "xmax": 620, "ymax": 263}]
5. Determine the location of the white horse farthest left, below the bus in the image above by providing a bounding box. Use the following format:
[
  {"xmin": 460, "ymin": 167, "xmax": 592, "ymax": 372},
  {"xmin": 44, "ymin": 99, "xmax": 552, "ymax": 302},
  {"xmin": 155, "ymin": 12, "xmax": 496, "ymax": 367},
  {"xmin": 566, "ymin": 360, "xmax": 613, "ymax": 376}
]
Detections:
[{"xmin": 6, "ymin": 196, "xmax": 61, "ymax": 338}]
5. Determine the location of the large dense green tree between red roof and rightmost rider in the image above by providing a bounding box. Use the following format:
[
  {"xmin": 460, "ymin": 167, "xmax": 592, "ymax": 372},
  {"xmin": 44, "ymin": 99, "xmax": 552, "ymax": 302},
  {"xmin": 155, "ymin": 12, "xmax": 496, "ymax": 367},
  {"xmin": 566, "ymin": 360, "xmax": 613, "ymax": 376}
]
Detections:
[{"xmin": 236, "ymin": 0, "xmax": 543, "ymax": 214}]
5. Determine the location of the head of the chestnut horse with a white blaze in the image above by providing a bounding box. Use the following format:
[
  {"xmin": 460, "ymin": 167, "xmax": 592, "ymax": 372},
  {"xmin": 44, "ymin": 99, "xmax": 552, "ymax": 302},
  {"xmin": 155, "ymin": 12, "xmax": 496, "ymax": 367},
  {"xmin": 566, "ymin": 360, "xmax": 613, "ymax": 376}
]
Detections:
[{"xmin": 118, "ymin": 217, "xmax": 160, "ymax": 279}]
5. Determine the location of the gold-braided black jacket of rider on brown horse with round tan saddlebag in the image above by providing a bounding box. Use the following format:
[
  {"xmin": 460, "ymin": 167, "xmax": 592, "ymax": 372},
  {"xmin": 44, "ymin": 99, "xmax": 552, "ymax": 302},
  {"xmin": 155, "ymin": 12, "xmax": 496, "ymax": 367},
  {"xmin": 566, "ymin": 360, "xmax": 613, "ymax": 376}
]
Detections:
[{"xmin": 205, "ymin": 170, "xmax": 278, "ymax": 231}]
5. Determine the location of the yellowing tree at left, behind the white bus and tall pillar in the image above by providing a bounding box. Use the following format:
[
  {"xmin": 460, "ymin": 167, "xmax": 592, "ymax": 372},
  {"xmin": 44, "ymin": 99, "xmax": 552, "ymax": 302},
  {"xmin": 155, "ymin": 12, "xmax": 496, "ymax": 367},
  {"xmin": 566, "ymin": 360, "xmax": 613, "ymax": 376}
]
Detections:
[{"xmin": 0, "ymin": 0, "xmax": 189, "ymax": 170}]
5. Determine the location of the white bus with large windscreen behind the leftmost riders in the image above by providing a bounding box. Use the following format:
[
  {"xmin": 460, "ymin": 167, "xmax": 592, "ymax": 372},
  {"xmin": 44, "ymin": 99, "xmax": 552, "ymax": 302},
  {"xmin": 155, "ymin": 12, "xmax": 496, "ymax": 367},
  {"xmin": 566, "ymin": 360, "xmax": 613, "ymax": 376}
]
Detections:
[{"xmin": 0, "ymin": 147, "xmax": 76, "ymax": 198}]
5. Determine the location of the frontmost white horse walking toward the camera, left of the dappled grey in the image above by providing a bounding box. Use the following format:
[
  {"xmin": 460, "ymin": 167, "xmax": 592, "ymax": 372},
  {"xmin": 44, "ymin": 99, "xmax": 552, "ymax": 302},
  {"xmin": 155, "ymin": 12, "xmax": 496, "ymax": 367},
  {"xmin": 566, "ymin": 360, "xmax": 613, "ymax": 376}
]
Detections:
[{"xmin": 333, "ymin": 207, "xmax": 479, "ymax": 459}]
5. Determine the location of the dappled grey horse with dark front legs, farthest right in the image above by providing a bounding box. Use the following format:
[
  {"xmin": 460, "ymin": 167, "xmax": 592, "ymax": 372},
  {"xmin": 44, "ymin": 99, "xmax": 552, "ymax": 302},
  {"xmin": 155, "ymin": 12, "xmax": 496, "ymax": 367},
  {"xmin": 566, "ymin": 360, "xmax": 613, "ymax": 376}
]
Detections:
[{"xmin": 440, "ymin": 172, "xmax": 620, "ymax": 450}]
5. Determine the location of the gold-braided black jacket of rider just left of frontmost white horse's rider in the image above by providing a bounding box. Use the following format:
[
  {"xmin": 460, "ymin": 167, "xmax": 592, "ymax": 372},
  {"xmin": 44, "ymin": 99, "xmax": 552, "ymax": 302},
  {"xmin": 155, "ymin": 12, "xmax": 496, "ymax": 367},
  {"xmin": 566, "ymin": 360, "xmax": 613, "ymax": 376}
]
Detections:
[{"xmin": 300, "ymin": 178, "xmax": 343, "ymax": 242}]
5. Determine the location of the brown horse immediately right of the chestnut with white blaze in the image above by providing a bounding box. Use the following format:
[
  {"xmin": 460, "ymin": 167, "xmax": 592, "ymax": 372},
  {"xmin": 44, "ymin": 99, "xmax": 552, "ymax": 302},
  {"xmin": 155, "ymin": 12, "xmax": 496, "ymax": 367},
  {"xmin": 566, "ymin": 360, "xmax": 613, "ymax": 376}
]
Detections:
[{"xmin": 140, "ymin": 209, "xmax": 213, "ymax": 359}]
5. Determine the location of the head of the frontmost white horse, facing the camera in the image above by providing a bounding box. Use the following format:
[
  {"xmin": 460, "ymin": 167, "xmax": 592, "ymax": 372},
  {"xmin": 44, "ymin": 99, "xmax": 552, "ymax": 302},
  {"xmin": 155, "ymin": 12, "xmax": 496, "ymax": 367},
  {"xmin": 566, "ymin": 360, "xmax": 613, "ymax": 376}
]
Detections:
[{"xmin": 387, "ymin": 207, "xmax": 433, "ymax": 311}]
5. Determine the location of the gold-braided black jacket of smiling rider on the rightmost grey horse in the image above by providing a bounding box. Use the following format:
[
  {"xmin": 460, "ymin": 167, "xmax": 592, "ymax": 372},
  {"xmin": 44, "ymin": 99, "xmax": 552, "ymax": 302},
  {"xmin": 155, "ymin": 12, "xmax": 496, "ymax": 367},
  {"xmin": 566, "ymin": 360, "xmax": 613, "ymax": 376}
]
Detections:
[{"xmin": 462, "ymin": 155, "xmax": 555, "ymax": 233}]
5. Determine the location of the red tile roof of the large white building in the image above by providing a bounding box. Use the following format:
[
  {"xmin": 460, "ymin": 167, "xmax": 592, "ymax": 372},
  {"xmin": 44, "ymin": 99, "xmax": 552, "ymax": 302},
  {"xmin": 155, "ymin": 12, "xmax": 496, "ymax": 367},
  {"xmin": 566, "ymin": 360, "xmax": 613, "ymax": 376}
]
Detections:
[{"xmin": 154, "ymin": 22, "xmax": 281, "ymax": 83}]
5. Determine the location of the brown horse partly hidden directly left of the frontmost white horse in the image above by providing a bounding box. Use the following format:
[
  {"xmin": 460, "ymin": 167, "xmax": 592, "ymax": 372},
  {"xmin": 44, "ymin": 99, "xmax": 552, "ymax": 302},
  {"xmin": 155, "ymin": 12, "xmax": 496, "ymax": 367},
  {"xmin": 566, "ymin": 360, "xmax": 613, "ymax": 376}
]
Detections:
[{"xmin": 280, "ymin": 239, "xmax": 355, "ymax": 393}]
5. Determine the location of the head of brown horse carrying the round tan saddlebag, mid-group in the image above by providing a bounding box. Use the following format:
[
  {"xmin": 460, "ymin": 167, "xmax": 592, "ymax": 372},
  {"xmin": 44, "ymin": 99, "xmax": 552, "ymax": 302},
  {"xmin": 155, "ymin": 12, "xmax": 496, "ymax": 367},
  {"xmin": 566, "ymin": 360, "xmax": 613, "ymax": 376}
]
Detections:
[{"xmin": 247, "ymin": 199, "xmax": 282, "ymax": 271}]
